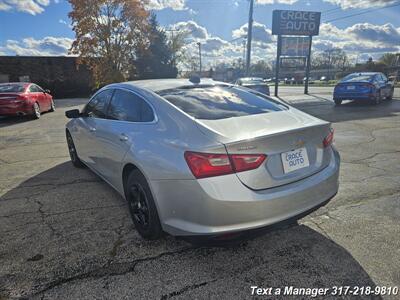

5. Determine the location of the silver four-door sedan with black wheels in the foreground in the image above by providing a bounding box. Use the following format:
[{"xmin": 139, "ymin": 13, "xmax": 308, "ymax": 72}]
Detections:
[{"xmin": 66, "ymin": 78, "xmax": 340, "ymax": 239}]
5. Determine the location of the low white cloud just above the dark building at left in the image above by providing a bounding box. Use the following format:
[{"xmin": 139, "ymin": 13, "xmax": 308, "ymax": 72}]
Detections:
[{"xmin": 1, "ymin": 36, "xmax": 73, "ymax": 56}]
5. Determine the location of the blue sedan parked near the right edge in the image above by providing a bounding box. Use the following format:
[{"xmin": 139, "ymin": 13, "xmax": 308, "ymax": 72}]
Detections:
[{"xmin": 333, "ymin": 72, "xmax": 394, "ymax": 105}]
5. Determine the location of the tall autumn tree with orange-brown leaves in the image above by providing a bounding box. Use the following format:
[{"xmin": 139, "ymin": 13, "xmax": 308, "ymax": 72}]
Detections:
[{"xmin": 68, "ymin": 0, "xmax": 149, "ymax": 87}]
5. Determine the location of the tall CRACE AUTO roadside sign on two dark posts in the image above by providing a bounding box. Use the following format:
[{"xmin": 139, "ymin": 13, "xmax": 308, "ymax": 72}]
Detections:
[{"xmin": 272, "ymin": 10, "xmax": 321, "ymax": 96}]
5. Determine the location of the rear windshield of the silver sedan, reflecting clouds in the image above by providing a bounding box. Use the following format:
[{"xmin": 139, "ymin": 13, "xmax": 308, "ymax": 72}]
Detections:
[{"xmin": 158, "ymin": 86, "xmax": 286, "ymax": 120}]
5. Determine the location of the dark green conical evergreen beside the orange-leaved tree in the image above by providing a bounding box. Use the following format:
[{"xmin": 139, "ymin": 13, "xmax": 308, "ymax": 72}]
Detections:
[{"xmin": 131, "ymin": 14, "xmax": 178, "ymax": 79}]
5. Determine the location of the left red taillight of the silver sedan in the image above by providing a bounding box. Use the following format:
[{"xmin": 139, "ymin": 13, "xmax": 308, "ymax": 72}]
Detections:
[{"xmin": 185, "ymin": 151, "xmax": 266, "ymax": 178}]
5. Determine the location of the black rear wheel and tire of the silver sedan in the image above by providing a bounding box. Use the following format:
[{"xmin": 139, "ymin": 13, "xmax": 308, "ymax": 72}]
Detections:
[{"xmin": 125, "ymin": 170, "xmax": 162, "ymax": 240}]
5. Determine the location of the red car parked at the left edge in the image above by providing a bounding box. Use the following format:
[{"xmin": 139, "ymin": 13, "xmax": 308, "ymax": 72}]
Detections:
[{"xmin": 0, "ymin": 82, "xmax": 55, "ymax": 119}]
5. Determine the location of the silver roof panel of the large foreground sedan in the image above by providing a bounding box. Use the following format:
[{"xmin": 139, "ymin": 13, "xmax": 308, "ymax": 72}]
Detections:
[{"xmin": 121, "ymin": 78, "xmax": 227, "ymax": 92}]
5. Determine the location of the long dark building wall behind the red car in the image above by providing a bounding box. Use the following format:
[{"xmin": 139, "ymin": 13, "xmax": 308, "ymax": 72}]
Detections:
[{"xmin": 0, "ymin": 56, "xmax": 92, "ymax": 98}]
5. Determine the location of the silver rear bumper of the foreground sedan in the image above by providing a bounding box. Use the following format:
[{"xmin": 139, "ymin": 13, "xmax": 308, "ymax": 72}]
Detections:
[{"xmin": 150, "ymin": 148, "xmax": 340, "ymax": 236}]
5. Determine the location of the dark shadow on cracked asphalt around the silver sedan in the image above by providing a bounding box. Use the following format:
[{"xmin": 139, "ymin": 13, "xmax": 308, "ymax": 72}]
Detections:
[{"xmin": 0, "ymin": 162, "xmax": 379, "ymax": 299}]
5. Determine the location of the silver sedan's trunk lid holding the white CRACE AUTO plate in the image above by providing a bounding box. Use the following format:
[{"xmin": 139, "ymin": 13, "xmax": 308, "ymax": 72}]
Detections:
[{"xmin": 199, "ymin": 109, "xmax": 331, "ymax": 190}]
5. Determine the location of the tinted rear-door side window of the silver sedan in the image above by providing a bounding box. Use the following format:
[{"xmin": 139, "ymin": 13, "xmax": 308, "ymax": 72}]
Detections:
[{"xmin": 108, "ymin": 90, "xmax": 154, "ymax": 122}]
